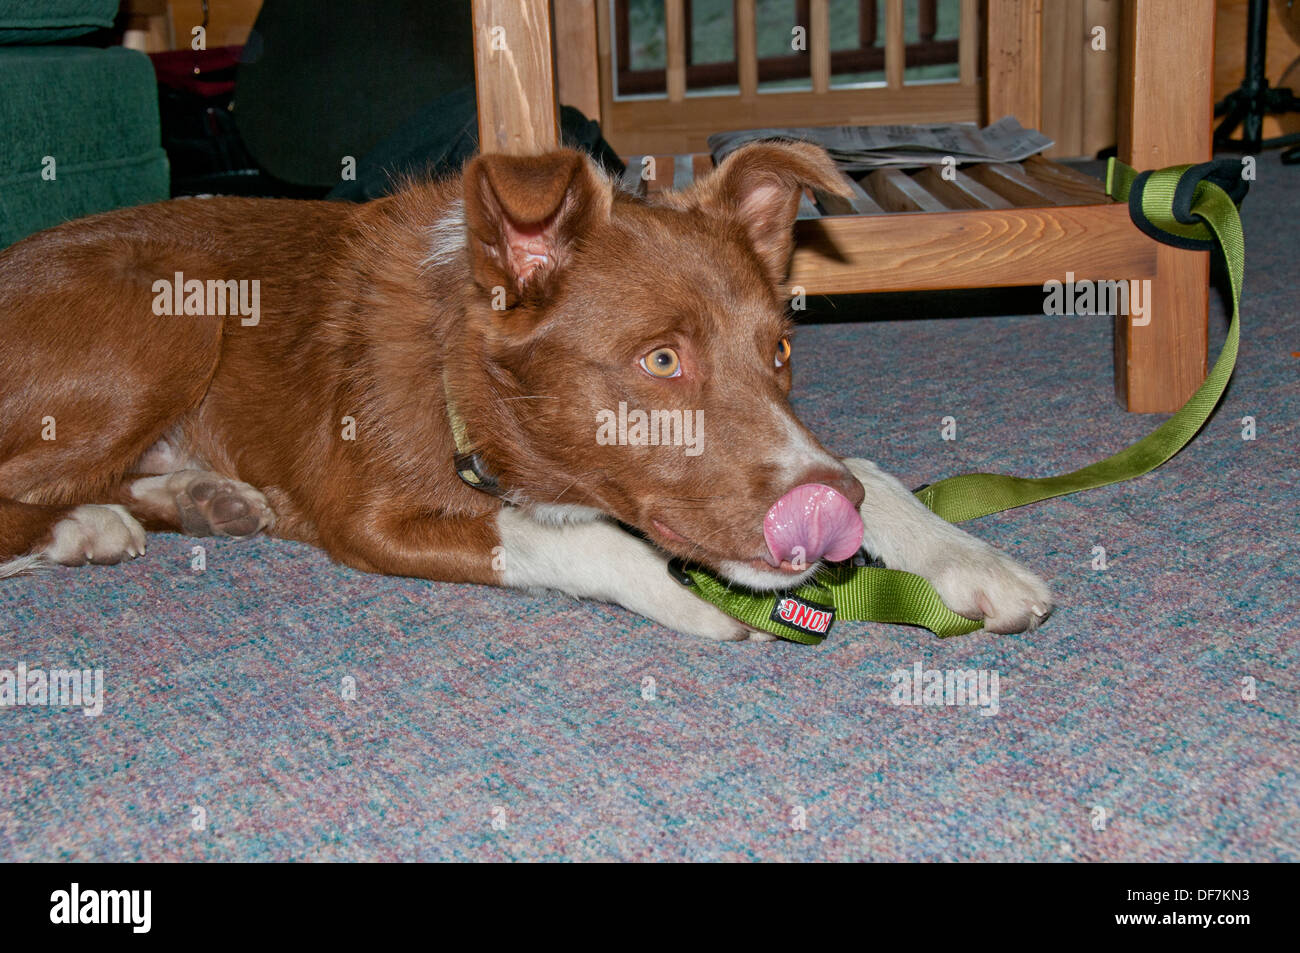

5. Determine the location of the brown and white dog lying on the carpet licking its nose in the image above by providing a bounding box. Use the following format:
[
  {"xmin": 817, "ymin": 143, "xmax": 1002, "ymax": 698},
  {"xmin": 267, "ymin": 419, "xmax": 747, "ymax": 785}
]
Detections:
[{"xmin": 0, "ymin": 143, "xmax": 1050, "ymax": 638}]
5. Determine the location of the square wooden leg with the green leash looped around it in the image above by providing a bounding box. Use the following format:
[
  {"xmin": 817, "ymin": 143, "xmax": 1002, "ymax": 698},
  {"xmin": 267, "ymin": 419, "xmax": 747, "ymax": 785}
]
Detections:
[{"xmin": 1115, "ymin": 0, "xmax": 1214, "ymax": 413}]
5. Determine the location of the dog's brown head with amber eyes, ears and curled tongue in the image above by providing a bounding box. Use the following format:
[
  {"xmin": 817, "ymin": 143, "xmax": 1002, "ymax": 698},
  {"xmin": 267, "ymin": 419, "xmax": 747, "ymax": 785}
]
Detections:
[{"xmin": 456, "ymin": 143, "xmax": 863, "ymax": 589}]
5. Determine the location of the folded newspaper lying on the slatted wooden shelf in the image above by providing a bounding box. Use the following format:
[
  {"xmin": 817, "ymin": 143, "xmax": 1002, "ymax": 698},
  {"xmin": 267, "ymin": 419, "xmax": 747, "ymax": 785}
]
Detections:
[{"xmin": 709, "ymin": 116, "xmax": 1052, "ymax": 172}]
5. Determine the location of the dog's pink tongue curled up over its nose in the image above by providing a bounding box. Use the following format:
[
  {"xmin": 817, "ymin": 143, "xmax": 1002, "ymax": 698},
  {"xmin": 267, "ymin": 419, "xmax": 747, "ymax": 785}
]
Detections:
[{"xmin": 763, "ymin": 484, "xmax": 862, "ymax": 566}]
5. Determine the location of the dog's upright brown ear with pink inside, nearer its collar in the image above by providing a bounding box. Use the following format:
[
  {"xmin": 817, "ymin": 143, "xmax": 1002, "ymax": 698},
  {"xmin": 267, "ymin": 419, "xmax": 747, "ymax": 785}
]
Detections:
[{"xmin": 464, "ymin": 150, "xmax": 612, "ymax": 306}]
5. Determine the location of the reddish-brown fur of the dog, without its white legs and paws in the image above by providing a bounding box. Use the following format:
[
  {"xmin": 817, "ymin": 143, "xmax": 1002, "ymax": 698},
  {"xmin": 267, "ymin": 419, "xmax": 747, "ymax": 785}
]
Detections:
[{"xmin": 0, "ymin": 144, "xmax": 862, "ymax": 582}]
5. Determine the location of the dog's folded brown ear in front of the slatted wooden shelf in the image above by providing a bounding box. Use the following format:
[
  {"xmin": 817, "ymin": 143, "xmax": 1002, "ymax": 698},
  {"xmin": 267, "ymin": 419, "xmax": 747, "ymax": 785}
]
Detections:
[{"xmin": 680, "ymin": 142, "xmax": 850, "ymax": 283}]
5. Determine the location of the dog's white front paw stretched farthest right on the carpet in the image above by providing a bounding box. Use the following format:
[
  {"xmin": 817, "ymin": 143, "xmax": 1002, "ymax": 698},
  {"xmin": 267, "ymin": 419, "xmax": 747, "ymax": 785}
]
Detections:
[{"xmin": 922, "ymin": 538, "xmax": 1052, "ymax": 633}]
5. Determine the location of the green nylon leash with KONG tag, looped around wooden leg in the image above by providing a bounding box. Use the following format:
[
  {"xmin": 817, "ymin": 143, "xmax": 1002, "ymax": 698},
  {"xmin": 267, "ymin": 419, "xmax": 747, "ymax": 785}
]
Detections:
[{"xmin": 673, "ymin": 159, "xmax": 1247, "ymax": 645}]
